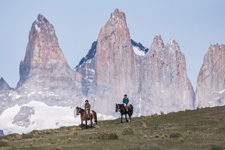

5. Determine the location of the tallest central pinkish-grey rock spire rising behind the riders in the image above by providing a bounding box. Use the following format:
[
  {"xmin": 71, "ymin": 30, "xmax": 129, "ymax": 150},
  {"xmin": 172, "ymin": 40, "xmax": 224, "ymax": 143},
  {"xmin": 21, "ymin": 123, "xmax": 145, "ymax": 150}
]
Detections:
[{"xmin": 77, "ymin": 9, "xmax": 135, "ymax": 114}]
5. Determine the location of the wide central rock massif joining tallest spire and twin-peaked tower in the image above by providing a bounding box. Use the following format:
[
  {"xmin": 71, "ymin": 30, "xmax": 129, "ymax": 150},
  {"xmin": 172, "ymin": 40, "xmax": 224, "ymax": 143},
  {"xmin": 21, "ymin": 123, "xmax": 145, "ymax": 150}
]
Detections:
[{"xmin": 77, "ymin": 9, "xmax": 194, "ymax": 115}]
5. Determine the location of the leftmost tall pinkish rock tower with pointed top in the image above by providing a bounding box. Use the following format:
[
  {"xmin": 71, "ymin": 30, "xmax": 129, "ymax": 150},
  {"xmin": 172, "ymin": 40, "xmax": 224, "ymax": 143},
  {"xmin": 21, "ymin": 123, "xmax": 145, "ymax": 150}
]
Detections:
[{"xmin": 11, "ymin": 15, "xmax": 78, "ymax": 106}]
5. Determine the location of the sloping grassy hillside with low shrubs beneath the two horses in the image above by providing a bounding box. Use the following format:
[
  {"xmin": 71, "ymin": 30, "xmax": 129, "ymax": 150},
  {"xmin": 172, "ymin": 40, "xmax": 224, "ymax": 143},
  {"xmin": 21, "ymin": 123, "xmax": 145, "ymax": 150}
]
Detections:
[{"xmin": 0, "ymin": 106, "xmax": 225, "ymax": 150}]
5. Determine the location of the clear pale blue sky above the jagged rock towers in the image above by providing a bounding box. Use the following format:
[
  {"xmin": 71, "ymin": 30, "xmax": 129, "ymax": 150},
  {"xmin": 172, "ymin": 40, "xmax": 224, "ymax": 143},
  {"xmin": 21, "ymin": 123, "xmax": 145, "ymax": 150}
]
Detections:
[{"xmin": 0, "ymin": 0, "xmax": 225, "ymax": 89}]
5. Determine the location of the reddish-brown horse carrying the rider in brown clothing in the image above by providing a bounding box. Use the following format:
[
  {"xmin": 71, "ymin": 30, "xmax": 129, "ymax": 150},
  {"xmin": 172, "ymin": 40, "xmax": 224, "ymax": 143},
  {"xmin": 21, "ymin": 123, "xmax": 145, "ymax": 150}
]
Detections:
[{"xmin": 76, "ymin": 107, "xmax": 97, "ymax": 129}]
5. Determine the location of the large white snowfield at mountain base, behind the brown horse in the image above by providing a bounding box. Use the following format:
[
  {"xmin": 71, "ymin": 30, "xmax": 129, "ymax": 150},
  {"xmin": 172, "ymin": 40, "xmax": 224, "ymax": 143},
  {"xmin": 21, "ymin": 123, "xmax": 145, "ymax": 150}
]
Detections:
[{"xmin": 0, "ymin": 101, "xmax": 115, "ymax": 135}]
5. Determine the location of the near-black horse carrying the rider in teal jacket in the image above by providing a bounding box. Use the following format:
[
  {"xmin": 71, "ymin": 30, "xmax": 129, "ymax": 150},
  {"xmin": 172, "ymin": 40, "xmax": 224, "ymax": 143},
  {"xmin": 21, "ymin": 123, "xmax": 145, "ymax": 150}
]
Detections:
[{"xmin": 116, "ymin": 104, "xmax": 133, "ymax": 123}]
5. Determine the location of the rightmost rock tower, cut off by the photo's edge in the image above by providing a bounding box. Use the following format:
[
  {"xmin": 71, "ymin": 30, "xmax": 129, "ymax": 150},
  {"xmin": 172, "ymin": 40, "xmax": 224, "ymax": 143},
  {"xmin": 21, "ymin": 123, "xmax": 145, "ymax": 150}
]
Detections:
[{"xmin": 195, "ymin": 44, "xmax": 225, "ymax": 107}]
